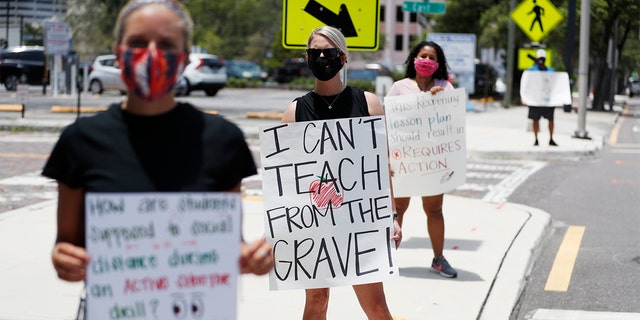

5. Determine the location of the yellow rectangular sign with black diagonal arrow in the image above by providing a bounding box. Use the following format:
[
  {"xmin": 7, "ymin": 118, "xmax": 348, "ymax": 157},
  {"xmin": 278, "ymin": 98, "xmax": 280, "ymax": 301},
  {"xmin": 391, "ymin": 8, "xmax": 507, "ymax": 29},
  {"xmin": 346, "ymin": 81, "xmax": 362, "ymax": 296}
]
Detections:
[{"xmin": 282, "ymin": 0, "xmax": 380, "ymax": 51}]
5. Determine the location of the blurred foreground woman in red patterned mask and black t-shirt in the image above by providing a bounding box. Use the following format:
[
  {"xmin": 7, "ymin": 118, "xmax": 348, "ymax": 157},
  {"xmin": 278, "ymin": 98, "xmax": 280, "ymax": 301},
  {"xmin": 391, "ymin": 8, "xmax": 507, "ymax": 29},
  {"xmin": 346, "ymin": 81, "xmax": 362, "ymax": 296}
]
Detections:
[{"xmin": 43, "ymin": 0, "xmax": 273, "ymax": 281}]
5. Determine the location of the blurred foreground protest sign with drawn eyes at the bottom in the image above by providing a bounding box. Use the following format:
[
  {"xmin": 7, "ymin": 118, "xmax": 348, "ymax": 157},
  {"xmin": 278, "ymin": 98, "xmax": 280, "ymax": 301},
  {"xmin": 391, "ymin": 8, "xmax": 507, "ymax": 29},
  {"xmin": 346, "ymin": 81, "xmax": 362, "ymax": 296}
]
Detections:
[{"xmin": 85, "ymin": 193, "xmax": 242, "ymax": 319}]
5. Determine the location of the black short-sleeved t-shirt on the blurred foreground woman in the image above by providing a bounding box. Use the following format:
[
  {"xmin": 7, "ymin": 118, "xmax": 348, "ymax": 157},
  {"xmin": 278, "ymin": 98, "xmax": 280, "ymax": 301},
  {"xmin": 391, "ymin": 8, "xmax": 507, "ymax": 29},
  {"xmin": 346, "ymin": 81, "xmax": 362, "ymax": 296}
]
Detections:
[{"xmin": 43, "ymin": 103, "xmax": 256, "ymax": 192}]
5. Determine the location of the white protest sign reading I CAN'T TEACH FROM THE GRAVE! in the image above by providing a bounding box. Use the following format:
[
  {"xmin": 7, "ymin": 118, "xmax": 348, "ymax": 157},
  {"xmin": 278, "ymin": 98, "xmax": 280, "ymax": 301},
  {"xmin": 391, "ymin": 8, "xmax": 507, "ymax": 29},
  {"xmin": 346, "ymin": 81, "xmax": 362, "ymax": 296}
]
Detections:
[{"xmin": 260, "ymin": 117, "xmax": 398, "ymax": 290}]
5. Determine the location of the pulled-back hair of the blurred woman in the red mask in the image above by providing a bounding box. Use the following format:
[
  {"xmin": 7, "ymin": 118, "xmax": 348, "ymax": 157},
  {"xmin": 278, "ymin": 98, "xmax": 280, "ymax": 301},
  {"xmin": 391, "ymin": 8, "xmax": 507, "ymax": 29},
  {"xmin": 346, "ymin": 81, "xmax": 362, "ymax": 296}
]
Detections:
[{"xmin": 113, "ymin": 0, "xmax": 193, "ymax": 52}]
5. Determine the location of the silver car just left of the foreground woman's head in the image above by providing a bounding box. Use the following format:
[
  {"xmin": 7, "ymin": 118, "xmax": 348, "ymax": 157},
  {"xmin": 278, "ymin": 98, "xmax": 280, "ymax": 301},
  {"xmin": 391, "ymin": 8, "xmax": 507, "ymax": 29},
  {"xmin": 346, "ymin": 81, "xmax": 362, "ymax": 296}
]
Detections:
[{"xmin": 89, "ymin": 54, "xmax": 127, "ymax": 94}]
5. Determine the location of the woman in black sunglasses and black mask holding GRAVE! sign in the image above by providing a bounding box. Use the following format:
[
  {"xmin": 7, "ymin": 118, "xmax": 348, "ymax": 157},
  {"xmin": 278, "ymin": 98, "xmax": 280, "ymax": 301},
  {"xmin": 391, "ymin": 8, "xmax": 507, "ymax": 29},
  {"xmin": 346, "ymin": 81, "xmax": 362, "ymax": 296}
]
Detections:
[{"xmin": 282, "ymin": 26, "xmax": 402, "ymax": 320}]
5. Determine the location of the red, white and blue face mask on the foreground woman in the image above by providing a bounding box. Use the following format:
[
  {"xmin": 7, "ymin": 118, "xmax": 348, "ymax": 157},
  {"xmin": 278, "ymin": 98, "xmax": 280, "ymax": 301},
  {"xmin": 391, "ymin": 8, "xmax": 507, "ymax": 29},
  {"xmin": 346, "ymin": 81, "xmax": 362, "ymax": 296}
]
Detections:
[{"xmin": 118, "ymin": 46, "xmax": 186, "ymax": 101}]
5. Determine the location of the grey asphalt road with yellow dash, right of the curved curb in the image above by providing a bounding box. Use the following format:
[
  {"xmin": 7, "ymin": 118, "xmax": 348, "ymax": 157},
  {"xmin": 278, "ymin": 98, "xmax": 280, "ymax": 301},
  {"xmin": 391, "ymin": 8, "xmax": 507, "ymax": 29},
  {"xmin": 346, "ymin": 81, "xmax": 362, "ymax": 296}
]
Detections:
[{"xmin": 509, "ymin": 101, "xmax": 640, "ymax": 320}]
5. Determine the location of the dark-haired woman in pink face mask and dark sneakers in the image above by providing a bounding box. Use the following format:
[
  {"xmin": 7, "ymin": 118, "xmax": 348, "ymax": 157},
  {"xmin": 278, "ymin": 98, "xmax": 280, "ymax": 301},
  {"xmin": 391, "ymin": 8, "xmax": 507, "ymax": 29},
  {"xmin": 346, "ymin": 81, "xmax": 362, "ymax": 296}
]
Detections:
[{"xmin": 387, "ymin": 41, "xmax": 458, "ymax": 278}]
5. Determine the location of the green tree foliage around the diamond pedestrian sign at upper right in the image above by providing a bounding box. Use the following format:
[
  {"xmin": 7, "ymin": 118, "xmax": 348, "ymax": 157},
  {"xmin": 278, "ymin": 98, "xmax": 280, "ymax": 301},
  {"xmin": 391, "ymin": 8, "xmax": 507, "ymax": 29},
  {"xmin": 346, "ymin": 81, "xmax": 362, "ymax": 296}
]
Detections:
[{"xmin": 434, "ymin": 0, "xmax": 640, "ymax": 110}]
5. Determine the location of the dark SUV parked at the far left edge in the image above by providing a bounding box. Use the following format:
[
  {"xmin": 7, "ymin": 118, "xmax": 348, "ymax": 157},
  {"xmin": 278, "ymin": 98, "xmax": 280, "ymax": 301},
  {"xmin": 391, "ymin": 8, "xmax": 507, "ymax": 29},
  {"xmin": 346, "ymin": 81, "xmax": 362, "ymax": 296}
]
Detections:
[{"xmin": 0, "ymin": 46, "xmax": 49, "ymax": 91}]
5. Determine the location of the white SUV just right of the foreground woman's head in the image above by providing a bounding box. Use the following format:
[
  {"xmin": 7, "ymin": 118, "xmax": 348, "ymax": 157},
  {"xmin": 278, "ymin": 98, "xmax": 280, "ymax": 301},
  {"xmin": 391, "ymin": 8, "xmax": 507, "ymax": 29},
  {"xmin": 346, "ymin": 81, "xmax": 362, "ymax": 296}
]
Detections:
[{"xmin": 182, "ymin": 53, "xmax": 227, "ymax": 96}]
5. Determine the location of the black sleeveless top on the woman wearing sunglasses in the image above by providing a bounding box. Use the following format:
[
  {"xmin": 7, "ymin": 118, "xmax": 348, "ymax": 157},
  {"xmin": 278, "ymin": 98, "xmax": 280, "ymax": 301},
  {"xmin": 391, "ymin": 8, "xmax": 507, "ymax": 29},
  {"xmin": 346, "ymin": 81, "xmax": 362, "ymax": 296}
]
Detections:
[{"xmin": 295, "ymin": 86, "xmax": 369, "ymax": 122}]
